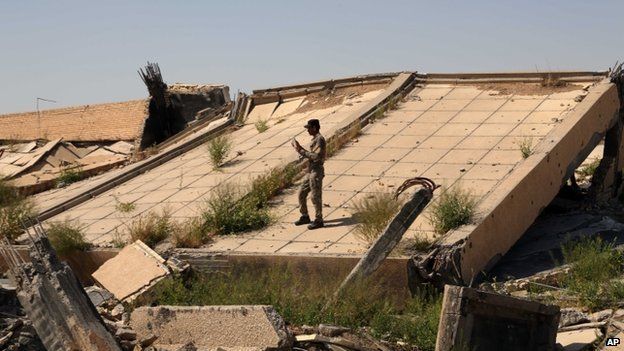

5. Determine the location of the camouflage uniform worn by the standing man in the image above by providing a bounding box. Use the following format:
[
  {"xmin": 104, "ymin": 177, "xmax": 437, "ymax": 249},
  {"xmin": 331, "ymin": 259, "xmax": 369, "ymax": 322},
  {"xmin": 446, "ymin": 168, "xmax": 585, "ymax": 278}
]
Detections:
[{"xmin": 299, "ymin": 133, "xmax": 327, "ymax": 222}]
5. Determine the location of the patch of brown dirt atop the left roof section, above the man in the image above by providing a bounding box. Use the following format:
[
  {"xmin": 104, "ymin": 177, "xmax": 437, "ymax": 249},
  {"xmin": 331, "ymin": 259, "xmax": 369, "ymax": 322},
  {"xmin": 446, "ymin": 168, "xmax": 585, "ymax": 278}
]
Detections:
[{"xmin": 295, "ymin": 83, "xmax": 388, "ymax": 113}]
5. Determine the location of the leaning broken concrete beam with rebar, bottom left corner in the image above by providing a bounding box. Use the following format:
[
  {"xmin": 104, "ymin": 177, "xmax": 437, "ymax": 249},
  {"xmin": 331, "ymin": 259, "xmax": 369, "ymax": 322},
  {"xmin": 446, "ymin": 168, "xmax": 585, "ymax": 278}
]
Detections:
[{"xmin": 0, "ymin": 225, "xmax": 120, "ymax": 351}]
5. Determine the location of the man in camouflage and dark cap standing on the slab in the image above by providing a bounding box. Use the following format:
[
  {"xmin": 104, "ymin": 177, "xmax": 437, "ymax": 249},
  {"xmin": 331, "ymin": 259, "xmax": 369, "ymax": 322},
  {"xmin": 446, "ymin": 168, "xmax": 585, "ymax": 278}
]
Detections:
[{"xmin": 292, "ymin": 119, "xmax": 327, "ymax": 229}]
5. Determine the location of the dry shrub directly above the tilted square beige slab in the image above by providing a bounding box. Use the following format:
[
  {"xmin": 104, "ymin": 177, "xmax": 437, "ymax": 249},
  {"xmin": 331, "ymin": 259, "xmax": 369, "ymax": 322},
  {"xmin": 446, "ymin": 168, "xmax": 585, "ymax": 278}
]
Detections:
[{"xmin": 127, "ymin": 209, "xmax": 172, "ymax": 248}]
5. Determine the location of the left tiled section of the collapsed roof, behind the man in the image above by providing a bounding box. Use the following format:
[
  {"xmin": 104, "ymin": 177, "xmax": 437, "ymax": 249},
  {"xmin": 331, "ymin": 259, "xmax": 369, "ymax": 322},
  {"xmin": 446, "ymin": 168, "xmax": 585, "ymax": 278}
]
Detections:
[{"xmin": 33, "ymin": 74, "xmax": 400, "ymax": 245}]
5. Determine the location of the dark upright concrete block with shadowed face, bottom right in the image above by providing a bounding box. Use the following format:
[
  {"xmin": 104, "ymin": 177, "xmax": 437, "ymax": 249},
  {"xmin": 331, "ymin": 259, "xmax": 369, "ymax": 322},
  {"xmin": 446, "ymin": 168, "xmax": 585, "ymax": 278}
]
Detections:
[{"xmin": 436, "ymin": 285, "xmax": 559, "ymax": 351}]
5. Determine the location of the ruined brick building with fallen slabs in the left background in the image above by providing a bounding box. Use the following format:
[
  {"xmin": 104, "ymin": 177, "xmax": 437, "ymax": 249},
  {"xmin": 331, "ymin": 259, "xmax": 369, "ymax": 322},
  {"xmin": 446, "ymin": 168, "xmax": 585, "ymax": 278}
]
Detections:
[{"xmin": 0, "ymin": 65, "xmax": 230, "ymax": 195}]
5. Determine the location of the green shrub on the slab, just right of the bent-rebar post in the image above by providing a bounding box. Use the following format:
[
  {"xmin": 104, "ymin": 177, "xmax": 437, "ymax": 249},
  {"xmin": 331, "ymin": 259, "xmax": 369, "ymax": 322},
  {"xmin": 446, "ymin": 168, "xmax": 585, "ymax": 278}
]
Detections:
[{"xmin": 429, "ymin": 187, "xmax": 476, "ymax": 234}]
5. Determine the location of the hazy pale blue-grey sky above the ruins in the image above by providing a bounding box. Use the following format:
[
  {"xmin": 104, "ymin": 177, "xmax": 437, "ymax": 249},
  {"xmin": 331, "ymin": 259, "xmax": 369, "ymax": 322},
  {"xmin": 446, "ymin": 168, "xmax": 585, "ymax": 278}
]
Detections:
[{"xmin": 0, "ymin": 0, "xmax": 624, "ymax": 113}]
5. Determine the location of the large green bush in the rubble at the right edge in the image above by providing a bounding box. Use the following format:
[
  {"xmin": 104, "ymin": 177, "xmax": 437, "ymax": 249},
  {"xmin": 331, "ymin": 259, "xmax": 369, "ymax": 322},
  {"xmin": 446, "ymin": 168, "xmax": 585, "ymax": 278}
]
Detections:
[{"xmin": 561, "ymin": 238, "xmax": 624, "ymax": 310}]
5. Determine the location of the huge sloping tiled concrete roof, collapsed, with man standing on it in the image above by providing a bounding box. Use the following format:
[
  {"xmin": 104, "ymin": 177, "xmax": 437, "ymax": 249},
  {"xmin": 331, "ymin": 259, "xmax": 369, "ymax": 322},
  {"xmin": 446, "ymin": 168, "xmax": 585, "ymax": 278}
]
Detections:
[{"xmin": 20, "ymin": 72, "xmax": 619, "ymax": 283}]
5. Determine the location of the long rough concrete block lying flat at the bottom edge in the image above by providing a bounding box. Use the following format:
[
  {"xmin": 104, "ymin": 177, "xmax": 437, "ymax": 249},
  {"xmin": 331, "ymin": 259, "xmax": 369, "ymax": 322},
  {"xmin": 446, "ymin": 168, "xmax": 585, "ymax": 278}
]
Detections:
[{"xmin": 130, "ymin": 306, "xmax": 293, "ymax": 350}]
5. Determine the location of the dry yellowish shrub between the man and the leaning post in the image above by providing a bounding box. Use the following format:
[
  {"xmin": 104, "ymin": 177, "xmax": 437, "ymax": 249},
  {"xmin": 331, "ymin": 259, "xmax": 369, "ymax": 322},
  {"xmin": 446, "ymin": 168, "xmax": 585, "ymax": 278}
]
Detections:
[{"xmin": 352, "ymin": 191, "xmax": 401, "ymax": 244}]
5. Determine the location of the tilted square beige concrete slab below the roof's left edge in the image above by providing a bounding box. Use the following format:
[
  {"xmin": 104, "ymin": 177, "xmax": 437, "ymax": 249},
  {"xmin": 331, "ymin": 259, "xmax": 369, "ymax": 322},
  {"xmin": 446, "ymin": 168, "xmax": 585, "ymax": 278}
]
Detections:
[{"xmin": 92, "ymin": 240, "xmax": 171, "ymax": 302}]
